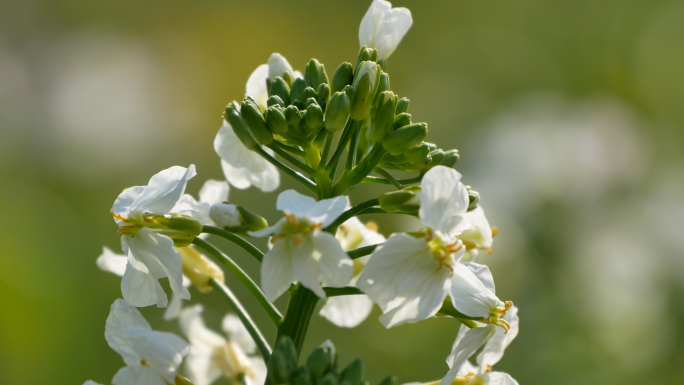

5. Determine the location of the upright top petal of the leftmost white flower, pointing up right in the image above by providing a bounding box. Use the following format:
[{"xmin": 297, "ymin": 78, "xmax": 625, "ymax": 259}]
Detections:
[{"xmin": 129, "ymin": 164, "xmax": 197, "ymax": 215}]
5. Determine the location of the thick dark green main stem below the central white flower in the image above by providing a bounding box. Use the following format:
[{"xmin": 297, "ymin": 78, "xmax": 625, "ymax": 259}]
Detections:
[{"xmin": 276, "ymin": 285, "xmax": 319, "ymax": 355}]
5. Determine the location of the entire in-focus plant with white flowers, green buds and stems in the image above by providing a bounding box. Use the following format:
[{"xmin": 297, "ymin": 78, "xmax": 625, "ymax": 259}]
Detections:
[{"xmin": 88, "ymin": 0, "xmax": 518, "ymax": 385}]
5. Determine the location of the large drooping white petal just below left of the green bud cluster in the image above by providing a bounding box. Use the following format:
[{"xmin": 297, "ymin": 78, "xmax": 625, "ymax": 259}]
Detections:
[{"xmin": 214, "ymin": 120, "xmax": 280, "ymax": 192}]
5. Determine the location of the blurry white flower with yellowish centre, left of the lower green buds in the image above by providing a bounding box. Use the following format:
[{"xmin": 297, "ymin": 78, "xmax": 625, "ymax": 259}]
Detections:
[{"xmin": 180, "ymin": 305, "xmax": 266, "ymax": 385}]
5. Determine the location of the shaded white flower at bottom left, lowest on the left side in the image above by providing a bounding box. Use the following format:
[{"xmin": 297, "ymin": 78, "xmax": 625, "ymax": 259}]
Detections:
[{"xmin": 105, "ymin": 299, "xmax": 188, "ymax": 385}]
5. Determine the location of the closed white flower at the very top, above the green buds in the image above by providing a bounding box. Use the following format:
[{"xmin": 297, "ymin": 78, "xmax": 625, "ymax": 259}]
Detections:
[{"xmin": 359, "ymin": 0, "xmax": 413, "ymax": 60}]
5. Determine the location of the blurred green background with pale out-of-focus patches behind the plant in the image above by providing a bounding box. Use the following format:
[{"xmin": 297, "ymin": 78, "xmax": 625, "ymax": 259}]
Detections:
[{"xmin": 0, "ymin": 0, "xmax": 684, "ymax": 385}]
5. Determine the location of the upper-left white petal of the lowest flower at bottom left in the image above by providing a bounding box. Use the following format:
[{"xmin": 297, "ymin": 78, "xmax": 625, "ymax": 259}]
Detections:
[{"xmin": 105, "ymin": 299, "xmax": 152, "ymax": 365}]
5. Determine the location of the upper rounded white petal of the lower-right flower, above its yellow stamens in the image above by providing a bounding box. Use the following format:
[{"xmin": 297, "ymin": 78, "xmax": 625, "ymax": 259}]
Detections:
[{"xmin": 451, "ymin": 263, "xmax": 503, "ymax": 318}]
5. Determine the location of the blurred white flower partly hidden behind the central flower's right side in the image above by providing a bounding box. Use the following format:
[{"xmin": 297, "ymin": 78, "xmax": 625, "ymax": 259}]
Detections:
[{"xmin": 319, "ymin": 217, "xmax": 385, "ymax": 328}]
